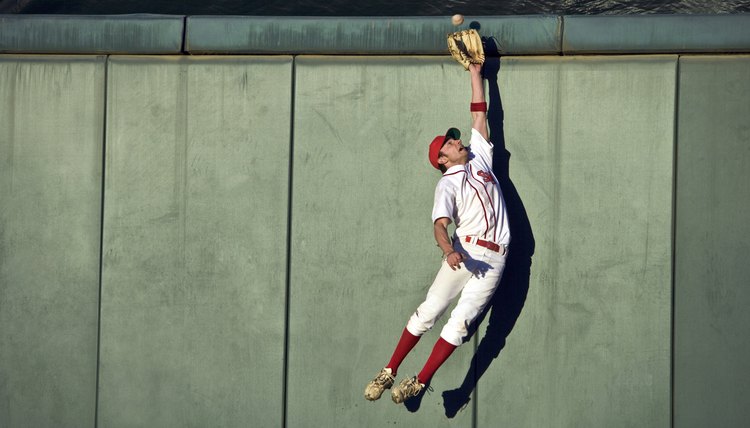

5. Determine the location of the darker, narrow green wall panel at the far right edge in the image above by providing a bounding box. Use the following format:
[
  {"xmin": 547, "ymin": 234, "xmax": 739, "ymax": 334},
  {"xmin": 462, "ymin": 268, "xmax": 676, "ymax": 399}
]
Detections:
[{"xmin": 674, "ymin": 56, "xmax": 750, "ymax": 427}]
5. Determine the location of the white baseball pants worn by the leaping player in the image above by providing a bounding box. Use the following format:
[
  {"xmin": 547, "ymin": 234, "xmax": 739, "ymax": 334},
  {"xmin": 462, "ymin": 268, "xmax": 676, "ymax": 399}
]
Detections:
[{"xmin": 406, "ymin": 239, "xmax": 507, "ymax": 346}]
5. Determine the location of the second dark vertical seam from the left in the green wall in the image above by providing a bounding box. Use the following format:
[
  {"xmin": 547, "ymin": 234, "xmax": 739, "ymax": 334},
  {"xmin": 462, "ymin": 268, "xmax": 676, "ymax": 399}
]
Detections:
[{"xmin": 281, "ymin": 55, "xmax": 297, "ymax": 427}]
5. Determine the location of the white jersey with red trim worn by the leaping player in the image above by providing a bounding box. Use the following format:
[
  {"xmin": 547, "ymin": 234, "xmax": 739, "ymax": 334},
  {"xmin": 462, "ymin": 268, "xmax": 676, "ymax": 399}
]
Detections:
[{"xmin": 432, "ymin": 129, "xmax": 510, "ymax": 245}]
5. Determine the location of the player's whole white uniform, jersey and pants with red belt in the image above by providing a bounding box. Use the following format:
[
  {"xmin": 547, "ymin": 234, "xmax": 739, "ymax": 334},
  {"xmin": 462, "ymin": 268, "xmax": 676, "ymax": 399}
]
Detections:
[{"xmin": 406, "ymin": 129, "xmax": 510, "ymax": 346}]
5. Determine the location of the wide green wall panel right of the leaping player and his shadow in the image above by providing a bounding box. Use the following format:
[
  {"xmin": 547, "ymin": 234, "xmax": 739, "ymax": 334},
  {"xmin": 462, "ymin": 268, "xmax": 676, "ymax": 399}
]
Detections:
[{"xmin": 477, "ymin": 56, "xmax": 677, "ymax": 427}]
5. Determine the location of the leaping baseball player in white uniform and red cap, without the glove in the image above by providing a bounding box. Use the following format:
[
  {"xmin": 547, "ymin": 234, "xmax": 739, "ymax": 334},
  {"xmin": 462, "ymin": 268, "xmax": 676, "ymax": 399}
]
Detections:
[{"xmin": 365, "ymin": 64, "xmax": 510, "ymax": 403}]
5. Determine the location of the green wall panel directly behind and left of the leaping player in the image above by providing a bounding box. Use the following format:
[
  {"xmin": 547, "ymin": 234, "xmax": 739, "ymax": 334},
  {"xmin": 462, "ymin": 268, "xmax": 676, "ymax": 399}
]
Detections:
[{"xmin": 288, "ymin": 57, "xmax": 482, "ymax": 427}]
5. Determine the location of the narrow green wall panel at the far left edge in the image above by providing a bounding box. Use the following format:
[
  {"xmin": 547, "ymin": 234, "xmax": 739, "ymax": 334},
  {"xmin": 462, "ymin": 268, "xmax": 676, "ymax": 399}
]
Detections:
[{"xmin": 0, "ymin": 55, "xmax": 105, "ymax": 427}]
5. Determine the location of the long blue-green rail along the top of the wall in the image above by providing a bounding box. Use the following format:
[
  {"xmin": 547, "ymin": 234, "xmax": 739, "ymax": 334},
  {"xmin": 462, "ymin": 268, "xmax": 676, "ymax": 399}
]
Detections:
[{"xmin": 0, "ymin": 14, "xmax": 750, "ymax": 55}]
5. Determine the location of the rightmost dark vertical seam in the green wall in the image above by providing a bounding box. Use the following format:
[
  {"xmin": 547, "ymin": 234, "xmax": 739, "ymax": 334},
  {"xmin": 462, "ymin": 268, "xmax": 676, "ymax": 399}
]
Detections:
[{"xmin": 669, "ymin": 55, "xmax": 681, "ymax": 427}]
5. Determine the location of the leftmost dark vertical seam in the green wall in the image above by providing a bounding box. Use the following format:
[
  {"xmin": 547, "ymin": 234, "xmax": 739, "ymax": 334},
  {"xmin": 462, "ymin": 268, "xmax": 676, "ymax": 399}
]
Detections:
[{"xmin": 94, "ymin": 55, "xmax": 109, "ymax": 427}]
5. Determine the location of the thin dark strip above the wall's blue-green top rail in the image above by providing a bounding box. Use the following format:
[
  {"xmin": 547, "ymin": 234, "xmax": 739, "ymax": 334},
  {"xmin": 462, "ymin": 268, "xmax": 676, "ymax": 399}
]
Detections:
[{"xmin": 5, "ymin": 0, "xmax": 750, "ymax": 16}]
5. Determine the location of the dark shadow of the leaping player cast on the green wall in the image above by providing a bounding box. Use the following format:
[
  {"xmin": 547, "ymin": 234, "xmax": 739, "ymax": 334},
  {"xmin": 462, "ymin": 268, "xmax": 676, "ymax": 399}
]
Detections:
[{"xmin": 442, "ymin": 38, "xmax": 535, "ymax": 418}]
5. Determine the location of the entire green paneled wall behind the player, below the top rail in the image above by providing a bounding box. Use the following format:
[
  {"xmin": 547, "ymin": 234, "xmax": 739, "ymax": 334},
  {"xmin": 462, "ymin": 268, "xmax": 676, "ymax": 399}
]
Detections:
[{"xmin": 0, "ymin": 13, "xmax": 750, "ymax": 427}]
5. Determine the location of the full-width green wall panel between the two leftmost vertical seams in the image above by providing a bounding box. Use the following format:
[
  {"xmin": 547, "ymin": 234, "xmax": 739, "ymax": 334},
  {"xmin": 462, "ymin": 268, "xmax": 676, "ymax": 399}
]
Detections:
[{"xmin": 98, "ymin": 57, "xmax": 292, "ymax": 427}]
